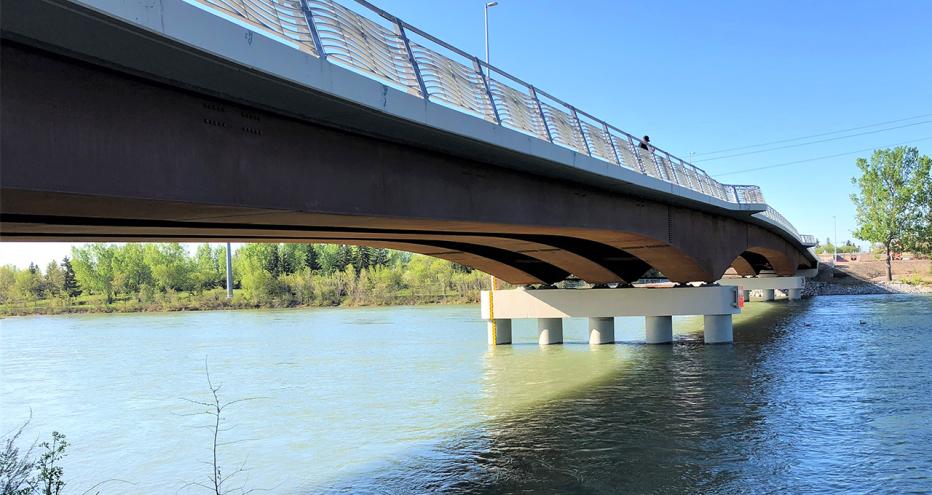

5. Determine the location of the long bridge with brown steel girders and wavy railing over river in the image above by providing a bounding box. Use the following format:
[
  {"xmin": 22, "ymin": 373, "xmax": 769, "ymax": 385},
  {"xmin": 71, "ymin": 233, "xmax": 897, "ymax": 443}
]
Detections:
[{"xmin": 0, "ymin": 0, "xmax": 818, "ymax": 343}]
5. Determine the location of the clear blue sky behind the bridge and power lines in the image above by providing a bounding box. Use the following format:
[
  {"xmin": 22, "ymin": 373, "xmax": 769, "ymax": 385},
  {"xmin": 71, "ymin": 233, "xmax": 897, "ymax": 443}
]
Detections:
[{"xmin": 0, "ymin": 0, "xmax": 932, "ymax": 265}]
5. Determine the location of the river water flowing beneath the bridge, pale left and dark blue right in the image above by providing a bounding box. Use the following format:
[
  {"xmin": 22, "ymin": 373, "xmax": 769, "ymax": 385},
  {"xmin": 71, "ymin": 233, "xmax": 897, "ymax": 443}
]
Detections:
[{"xmin": 0, "ymin": 295, "xmax": 932, "ymax": 494}]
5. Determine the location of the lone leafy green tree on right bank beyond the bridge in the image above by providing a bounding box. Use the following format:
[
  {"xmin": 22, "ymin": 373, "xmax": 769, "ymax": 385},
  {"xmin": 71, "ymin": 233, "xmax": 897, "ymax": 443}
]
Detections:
[{"xmin": 851, "ymin": 146, "xmax": 932, "ymax": 280}]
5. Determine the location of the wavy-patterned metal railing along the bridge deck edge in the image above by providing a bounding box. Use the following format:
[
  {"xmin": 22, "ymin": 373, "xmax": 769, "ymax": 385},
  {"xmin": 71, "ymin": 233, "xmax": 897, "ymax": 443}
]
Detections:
[{"xmin": 187, "ymin": 0, "xmax": 799, "ymax": 246}]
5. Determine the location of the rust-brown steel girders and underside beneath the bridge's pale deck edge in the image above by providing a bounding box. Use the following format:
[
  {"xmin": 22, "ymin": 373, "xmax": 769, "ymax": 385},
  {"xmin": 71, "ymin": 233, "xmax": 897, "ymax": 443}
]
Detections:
[{"xmin": 0, "ymin": 40, "xmax": 810, "ymax": 284}]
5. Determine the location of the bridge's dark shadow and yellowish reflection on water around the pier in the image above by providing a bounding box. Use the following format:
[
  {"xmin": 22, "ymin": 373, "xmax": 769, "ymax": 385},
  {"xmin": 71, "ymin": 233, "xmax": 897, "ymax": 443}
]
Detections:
[{"xmin": 312, "ymin": 301, "xmax": 832, "ymax": 494}]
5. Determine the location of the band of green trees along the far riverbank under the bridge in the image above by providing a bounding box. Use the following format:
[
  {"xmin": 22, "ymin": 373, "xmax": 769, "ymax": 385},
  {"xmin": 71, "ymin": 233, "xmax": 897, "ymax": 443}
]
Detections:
[{"xmin": 0, "ymin": 243, "xmax": 488, "ymax": 313}]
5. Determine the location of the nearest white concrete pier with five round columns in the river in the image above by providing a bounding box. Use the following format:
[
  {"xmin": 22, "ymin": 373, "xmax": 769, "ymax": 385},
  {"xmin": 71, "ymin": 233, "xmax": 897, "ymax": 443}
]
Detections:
[{"xmin": 482, "ymin": 286, "xmax": 741, "ymax": 345}]
